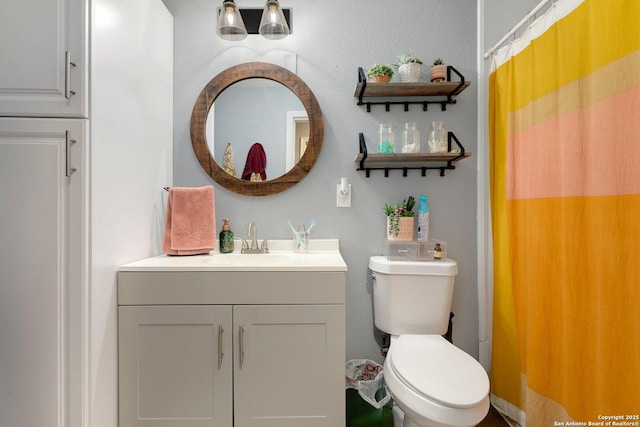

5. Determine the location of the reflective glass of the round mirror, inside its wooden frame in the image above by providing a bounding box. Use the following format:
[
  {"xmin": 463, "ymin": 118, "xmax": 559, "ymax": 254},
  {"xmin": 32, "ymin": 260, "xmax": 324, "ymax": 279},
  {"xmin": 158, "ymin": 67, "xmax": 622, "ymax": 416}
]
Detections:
[{"xmin": 206, "ymin": 78, "xmax": 309, "ymax": 182}]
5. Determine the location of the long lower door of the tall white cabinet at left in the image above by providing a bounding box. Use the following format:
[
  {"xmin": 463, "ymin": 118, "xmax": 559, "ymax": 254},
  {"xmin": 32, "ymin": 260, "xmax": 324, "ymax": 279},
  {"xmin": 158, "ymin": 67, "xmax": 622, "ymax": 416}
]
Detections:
[{"xmin": 0, "ymin": 118, "xmax": 87, "ymax": 427}]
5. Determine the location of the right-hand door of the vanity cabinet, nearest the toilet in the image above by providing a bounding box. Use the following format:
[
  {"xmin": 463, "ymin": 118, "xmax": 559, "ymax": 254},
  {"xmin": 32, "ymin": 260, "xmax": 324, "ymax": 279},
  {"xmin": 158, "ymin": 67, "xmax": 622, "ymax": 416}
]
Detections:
[{"xmin": 233, "ymin": 305, "xmax": 345, "ymax": 427}]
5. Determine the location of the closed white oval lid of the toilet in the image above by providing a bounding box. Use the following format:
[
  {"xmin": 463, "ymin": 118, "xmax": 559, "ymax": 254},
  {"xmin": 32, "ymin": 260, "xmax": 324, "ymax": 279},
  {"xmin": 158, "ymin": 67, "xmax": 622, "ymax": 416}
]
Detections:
[{"xmin": 390, "ymin": 335, "xmax": 489, "ymax": 408}]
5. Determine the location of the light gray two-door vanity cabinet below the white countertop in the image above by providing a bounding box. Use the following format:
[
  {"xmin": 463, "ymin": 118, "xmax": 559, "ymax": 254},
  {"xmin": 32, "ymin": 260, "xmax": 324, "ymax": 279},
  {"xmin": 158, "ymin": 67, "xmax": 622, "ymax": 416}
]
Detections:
[{"xmin": 118, "ymin": 271, "xmax": 345, "ymax": 427}]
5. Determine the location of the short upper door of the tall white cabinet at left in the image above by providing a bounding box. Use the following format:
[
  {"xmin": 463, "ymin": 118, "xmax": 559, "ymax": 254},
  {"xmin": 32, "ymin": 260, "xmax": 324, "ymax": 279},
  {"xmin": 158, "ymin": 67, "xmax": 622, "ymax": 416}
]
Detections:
[{"xmin": 0, "ymin": 0, "xmax": 87, "ymax": 117}]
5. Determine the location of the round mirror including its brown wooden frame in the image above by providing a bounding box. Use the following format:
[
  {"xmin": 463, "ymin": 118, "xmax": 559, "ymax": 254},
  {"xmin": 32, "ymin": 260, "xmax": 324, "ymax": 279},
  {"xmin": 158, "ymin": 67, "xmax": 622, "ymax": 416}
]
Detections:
[{"xmin": 190, "ymin": 62, "xmax": 324, "ymax": 196}]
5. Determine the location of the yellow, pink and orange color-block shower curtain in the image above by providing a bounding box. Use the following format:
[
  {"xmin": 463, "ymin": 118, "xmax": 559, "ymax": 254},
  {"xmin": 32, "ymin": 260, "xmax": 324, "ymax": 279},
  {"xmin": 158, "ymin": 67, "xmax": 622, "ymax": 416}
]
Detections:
[{"xmin": 489, "ymin": 0, "xmax": 640, "ymax": 427}]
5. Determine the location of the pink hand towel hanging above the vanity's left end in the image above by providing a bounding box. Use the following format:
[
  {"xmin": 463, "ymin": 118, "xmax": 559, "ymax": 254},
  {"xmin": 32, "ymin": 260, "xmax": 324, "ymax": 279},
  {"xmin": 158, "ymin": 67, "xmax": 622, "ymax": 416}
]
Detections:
[{"xmin": 162, "ymin": 185, "xmax": 216, "ymax": 255}]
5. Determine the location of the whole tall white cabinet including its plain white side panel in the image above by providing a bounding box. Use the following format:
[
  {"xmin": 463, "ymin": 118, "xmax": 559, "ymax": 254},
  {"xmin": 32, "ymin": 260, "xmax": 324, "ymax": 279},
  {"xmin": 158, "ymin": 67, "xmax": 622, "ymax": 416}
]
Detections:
[{"xmin": 0, "ymin": 0, "xmax": 173, "ymax": 427}]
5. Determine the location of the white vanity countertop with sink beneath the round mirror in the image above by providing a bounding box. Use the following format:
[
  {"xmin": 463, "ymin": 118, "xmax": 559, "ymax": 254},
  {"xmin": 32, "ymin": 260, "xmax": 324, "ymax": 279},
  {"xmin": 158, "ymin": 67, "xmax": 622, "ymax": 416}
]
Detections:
[{"xmin": 118, "ymin": 239, "xmax": 347, "ymax": 271}]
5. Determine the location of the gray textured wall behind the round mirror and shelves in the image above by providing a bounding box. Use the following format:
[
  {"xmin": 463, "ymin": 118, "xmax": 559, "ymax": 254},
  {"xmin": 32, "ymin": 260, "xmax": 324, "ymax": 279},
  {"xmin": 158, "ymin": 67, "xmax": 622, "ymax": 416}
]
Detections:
[{"xmin": 164, "ymin": 0, "xmax": 478, "ymax": 360}]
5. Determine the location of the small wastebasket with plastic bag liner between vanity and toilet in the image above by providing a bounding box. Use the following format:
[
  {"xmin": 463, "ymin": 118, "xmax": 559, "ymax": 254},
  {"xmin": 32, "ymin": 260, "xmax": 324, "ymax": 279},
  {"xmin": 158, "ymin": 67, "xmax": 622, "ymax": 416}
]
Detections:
[{"xmin": 345, "ymin": 359, "xmax": 393, "ymax": 427}]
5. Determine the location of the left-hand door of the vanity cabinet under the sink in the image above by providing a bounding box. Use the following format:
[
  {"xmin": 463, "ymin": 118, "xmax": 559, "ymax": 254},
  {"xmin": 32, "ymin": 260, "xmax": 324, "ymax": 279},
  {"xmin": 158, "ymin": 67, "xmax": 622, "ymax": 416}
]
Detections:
[{"xmin": 118, "ymin": 306, "xmax": 233, "ymax": 427}]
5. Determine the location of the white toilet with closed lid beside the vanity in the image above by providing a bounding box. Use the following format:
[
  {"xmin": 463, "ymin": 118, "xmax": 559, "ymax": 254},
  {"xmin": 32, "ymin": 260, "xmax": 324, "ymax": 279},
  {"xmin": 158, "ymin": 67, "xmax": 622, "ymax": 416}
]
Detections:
[{"xmin": 369, "ymin": 256, "xmax": 489, "ymax": 427}]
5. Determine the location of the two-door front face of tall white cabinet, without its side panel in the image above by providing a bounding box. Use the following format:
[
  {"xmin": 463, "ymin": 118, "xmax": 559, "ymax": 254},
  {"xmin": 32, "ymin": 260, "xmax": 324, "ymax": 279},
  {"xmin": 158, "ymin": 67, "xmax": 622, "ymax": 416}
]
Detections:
[{"xmin": 0, "ymin": 0, "xmax": 89, "ymax": 427}]
